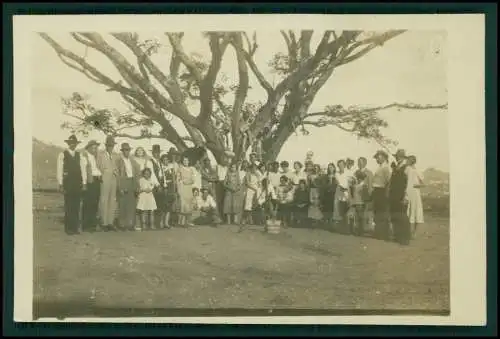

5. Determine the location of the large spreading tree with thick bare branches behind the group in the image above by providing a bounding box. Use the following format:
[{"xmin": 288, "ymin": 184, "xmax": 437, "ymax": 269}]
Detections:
[{"xmin": 40, "ymin": 30, "xmax": 446, "ymax": 161}]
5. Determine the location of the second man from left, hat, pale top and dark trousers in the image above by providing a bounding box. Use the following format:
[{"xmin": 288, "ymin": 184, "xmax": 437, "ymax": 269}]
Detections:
[{"xmin": 82, "ymin": 140, "xmax": 101, "ymax": 232}]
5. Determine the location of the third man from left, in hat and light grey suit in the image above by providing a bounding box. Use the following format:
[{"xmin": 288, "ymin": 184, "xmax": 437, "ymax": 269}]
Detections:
[{"xmin": 97, "ymin": 136, "xmax": 120, "ymax": 231}]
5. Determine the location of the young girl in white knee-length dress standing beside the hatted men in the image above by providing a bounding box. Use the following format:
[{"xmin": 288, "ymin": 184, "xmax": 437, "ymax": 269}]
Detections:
[{"xmin": 137, "ymin": 167, "xmax": 156, "ymax": 230}]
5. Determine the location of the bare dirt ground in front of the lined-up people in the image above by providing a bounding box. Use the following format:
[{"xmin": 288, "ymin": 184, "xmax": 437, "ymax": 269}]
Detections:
[{"xmin": 33, "ymin": 193, "xmax": 449, "ymax": 317}]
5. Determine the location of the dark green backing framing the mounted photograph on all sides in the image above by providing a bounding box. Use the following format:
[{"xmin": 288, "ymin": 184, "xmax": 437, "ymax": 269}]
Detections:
[{"xmin": 3, "ymin": 3, "xmax": 497, "ymax": 336}]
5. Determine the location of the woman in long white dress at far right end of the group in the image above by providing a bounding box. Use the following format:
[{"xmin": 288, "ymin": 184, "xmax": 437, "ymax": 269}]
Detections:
[{"xmin": 406, "ymin": 155, "xmax": 424, "ymax": 236}]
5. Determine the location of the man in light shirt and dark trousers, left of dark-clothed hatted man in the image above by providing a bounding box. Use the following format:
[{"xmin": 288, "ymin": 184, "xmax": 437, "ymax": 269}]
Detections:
[{"xmin": 372, "ymin": 151, "xmax": 391, "ymax": 240}]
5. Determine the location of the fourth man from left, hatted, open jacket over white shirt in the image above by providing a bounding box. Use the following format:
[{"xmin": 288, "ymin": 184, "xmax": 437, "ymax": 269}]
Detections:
[{"xmin": 117, "ymin": 142, "xmax": 140, "ymax": 231}]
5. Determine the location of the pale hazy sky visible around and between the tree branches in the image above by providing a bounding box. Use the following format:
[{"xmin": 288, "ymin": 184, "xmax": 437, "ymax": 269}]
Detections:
[{"xmin": 31, "ymin": 30, "xmax": 449, "ymax": 170}]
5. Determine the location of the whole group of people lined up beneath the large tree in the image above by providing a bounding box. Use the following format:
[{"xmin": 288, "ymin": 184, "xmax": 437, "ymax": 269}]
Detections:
[{"xmin": 57, "ymin": 135, "xmax": 423, "ymax": 244}]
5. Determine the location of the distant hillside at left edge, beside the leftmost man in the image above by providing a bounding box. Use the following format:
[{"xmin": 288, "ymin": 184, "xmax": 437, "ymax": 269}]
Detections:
[{"xmin": 31, "ymin": 138, "xmax": 63, "ymax": 189}]
